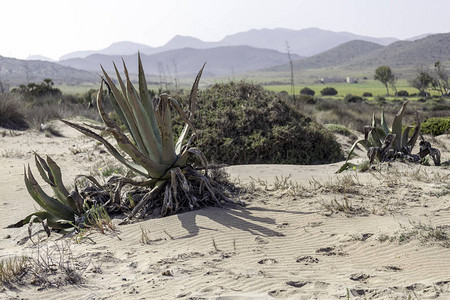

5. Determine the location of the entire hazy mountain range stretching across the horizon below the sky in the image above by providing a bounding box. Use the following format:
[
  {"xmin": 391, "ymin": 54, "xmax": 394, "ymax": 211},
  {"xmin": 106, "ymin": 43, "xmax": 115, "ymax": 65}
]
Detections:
[{"xmin": 0, "ymin": 28, "xmax": 450, "ymax": 86}]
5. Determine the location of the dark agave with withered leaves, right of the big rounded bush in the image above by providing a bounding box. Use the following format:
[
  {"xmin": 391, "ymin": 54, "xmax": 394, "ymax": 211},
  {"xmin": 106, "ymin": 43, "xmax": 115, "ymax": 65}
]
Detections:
[{"xmin": 338, "ymin": 101, "xmax": 436, "ymax": 173}]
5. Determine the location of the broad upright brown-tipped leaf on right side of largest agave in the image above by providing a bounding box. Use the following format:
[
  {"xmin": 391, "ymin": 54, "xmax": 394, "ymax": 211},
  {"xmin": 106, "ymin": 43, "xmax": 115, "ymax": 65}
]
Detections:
[{"xmin": 155, "ymin": 94, "xmax": 177, "ymax": 165}]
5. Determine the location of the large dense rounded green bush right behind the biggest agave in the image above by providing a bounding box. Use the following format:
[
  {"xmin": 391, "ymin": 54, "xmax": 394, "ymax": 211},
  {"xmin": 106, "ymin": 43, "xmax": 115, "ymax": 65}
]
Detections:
[{"xmin": 194, "ymin": 82, "xmax": 343, "ymax": 164}]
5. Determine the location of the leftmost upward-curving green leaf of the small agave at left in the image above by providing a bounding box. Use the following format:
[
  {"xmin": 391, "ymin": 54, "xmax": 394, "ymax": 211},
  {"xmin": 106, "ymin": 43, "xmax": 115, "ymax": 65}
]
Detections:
[{"xmin": 25, "ymin": 166, "xmax": 74, "ymax": 221}]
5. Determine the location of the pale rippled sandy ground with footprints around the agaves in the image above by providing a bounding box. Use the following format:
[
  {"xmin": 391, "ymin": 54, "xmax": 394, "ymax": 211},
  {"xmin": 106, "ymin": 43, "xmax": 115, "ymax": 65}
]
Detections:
[{"xmin": 0, "ymin": 120, "xmax": 450, "ymax": 299}]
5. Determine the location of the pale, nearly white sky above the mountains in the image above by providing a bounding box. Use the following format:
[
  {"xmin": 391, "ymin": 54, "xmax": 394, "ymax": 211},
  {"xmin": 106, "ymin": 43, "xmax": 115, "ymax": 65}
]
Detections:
[{"xmin": 0, "ymin": 0, "xmax": 450, "ymax": 59}]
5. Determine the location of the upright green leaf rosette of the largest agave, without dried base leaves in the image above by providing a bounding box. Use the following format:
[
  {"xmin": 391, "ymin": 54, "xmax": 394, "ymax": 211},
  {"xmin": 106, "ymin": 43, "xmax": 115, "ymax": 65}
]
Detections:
[{"xmin": 63, "ymin": 55, "xmax": 204, "ymax": 185}]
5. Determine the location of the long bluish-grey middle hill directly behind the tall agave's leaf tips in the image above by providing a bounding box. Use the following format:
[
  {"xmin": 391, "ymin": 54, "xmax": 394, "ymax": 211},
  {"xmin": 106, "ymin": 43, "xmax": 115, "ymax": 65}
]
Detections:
[{"xmin": 59, "ymin": 46, "xmax": 300, "ymax": 76}]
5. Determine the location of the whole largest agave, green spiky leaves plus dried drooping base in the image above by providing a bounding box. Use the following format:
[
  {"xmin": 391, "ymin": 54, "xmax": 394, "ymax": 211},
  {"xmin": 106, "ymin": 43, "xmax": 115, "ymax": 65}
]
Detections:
[{"xmin": 64, "ymin": 55, "xmax": 226, "ymax": 218}]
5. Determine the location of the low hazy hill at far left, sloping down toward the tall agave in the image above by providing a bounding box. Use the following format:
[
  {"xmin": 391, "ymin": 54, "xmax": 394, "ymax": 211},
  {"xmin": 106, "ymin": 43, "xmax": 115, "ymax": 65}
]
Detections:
[{"xmin": 0, "ymin": 56, "xmax": 98, "ymax": 87}]
